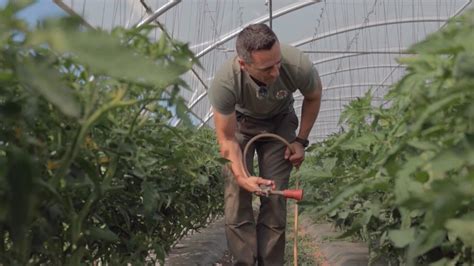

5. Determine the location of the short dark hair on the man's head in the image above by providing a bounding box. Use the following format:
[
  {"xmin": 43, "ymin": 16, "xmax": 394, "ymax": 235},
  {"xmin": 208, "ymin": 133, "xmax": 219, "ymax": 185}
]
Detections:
[{"xmin": 235, "ymin": 23, "xmax": 278, "ymax": 63}]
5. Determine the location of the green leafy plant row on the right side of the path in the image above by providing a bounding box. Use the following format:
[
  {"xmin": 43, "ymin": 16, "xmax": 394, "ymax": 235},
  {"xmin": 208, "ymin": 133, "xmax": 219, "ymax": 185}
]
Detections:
[{"xmin": 302, "ymin": 10, "xmax": 474, "ymax": 265}]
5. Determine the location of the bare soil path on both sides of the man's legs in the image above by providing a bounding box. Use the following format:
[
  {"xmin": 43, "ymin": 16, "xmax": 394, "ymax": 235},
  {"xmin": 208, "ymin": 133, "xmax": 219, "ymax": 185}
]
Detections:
[{"xmin": 165, "ymin": 207, "xmax": 385, "ymax": 266}]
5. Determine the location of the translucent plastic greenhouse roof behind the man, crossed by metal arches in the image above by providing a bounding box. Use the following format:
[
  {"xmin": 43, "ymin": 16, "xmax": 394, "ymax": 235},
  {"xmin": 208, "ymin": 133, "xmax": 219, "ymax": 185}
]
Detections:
[{"xmin": 54, "ymin": 0, "xmax": 472, "ymax": 142}]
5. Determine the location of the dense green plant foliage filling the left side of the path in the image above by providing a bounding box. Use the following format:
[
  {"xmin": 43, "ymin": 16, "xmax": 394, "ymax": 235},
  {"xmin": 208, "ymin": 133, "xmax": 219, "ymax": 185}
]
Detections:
[{"xmin": 0, "ymin": 1, "xmax": 223, "ymax": 265}]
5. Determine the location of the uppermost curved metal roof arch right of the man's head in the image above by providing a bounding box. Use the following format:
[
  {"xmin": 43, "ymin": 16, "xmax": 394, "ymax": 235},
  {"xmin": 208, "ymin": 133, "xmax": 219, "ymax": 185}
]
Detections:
[{"xmin": 291, "ymin": 17, "xmax": 449, "ymax": 47}]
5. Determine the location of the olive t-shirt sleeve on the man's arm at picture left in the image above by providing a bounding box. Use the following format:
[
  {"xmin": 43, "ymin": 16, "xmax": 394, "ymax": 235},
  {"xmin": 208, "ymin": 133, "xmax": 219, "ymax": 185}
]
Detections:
[{"xmin": 208, "ymin": 71, "xmax": 236, "ymax": 115}]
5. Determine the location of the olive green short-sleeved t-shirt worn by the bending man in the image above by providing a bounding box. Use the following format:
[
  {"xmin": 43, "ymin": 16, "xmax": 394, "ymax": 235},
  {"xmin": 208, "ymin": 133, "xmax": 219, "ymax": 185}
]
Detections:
[{"xmin": 208, "ymin": 44, "xmax": 318, "ymax": 119}]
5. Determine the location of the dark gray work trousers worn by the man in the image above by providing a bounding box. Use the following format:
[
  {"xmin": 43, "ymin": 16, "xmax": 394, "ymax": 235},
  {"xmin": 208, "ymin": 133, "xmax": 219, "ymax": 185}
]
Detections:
[{"xmin": 224, "ymin": 110, "xmax": 298, "ymax": 266}]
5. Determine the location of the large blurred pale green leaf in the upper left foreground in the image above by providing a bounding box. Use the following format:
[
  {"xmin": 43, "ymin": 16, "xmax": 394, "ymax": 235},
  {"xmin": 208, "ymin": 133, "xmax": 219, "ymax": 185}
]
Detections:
[{"xmin": 28, "ymin": 27, "xmax": 191, "ymax": 88}]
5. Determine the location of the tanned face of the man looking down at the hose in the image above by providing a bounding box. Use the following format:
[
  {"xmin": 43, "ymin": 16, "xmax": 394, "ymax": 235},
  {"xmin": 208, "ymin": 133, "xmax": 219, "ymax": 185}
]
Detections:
[{"xmin": 239, "ymin": 42, "xmax": 281, "ymax": 86}]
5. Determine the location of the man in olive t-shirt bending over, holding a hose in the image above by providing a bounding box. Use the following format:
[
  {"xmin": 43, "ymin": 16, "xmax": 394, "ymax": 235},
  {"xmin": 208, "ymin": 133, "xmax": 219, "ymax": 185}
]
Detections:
[{"xmin": 208, "ymin": 24, "xmax": 321, "ymax": 266}]
